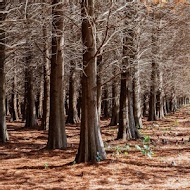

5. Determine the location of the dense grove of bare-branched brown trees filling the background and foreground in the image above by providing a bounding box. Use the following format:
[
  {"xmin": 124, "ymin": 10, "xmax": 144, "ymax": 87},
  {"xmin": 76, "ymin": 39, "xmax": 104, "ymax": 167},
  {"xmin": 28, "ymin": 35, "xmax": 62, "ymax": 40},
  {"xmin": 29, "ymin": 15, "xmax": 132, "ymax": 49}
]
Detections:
[{"xmin": 0, "ymin": 0, "xmax": 190, "ymax": 163}]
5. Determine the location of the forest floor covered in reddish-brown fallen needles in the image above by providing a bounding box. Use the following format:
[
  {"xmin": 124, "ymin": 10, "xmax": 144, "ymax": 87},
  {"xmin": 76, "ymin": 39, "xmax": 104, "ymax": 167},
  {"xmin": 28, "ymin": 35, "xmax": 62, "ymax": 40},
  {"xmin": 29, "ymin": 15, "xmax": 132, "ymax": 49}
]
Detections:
[{"xmin": 0, "ymin": 106, "xmax": 190, "ymax": 190}]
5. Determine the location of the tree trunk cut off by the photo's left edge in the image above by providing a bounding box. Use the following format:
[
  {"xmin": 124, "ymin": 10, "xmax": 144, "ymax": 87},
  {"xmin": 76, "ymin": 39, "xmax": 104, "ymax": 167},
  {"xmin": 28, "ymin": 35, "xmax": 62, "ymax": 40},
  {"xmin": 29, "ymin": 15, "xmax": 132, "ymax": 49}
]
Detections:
[{"xmin": 0, "ymin": 1, "xmax": 8, "ymax": 143}]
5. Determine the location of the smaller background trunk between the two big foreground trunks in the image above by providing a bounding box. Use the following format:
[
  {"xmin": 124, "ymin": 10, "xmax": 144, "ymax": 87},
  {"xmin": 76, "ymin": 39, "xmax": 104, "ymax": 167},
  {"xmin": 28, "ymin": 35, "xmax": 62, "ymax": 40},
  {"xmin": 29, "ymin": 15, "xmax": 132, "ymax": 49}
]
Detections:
[{"xmin": 66, "ymin": 63, "xmax": 80, "ymax": 124}]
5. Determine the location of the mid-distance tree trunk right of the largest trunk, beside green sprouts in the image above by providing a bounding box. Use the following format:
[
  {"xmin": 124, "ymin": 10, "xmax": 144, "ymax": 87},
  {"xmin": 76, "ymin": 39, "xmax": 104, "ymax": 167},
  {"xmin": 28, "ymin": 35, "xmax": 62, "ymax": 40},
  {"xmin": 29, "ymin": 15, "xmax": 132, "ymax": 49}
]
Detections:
[{"xmin": 118, "ymin": 0, "xmax": 140, "ymax": 139}]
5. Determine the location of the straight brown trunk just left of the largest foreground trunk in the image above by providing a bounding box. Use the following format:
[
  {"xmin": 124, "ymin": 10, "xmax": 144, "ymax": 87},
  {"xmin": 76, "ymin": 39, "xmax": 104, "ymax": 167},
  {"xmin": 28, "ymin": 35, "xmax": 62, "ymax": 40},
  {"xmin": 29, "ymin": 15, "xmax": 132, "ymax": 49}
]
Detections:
[{"xmin": 47, "ymin": 0, "xmax": 67, "ymax": 149}]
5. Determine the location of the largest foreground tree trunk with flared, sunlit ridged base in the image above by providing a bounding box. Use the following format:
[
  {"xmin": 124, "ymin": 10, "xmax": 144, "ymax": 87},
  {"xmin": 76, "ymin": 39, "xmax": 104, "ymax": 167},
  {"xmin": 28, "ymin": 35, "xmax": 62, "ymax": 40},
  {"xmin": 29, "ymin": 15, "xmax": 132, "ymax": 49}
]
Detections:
[{"xmin": 76, "ymin": 0, "xmax": 106, "ymax": 163}]
